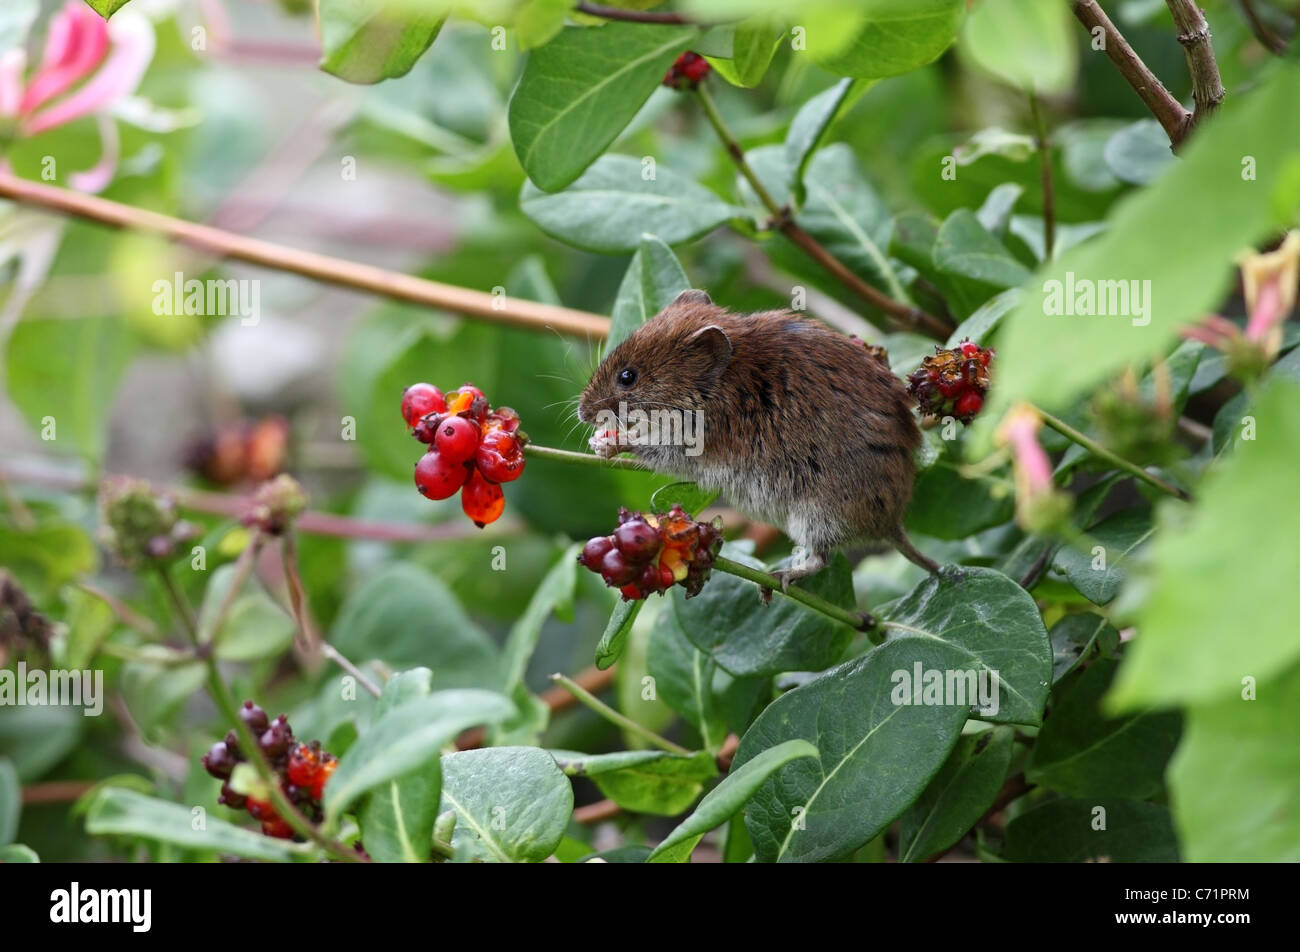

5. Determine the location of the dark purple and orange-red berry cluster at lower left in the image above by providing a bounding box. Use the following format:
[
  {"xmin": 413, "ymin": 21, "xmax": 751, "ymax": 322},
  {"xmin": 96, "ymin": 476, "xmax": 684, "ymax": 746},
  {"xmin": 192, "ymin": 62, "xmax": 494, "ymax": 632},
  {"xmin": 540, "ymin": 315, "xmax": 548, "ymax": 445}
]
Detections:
[{"xmin": 203, "ymin": 701, "xmax": 338, "ymax": 840}]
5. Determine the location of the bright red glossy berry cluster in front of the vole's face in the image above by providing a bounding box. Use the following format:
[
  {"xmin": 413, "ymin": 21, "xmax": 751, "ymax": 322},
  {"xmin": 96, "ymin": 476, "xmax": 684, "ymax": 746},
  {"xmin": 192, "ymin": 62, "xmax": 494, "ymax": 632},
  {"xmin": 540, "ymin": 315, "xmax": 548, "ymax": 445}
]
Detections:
[{"xmin": 402, "ymin": 384, "xmax": 524, "ymax": 529}]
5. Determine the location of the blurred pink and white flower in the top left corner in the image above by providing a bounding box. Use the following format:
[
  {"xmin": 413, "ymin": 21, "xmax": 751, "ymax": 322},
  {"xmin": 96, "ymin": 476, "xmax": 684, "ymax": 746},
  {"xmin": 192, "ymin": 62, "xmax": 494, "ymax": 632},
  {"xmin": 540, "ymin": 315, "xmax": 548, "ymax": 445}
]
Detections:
[{"xmin": 0, "ymin": 0, "xmax": 155, "ymax": 191}]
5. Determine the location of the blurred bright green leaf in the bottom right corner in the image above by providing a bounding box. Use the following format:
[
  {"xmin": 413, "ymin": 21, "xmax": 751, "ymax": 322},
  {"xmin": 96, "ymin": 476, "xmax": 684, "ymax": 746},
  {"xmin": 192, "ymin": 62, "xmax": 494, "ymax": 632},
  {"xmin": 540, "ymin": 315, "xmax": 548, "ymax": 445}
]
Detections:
[{"xmin": 1169, "ymin": 658, "xmax": 1300, "ymax": 862}]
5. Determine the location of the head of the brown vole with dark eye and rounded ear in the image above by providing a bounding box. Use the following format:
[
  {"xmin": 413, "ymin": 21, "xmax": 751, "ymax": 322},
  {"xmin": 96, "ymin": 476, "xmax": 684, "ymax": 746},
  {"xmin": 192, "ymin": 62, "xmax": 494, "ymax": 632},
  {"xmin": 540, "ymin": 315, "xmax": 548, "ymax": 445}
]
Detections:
[{"xmin": 577, "ymin": 290, "xmax": 732, "ymax": 424}]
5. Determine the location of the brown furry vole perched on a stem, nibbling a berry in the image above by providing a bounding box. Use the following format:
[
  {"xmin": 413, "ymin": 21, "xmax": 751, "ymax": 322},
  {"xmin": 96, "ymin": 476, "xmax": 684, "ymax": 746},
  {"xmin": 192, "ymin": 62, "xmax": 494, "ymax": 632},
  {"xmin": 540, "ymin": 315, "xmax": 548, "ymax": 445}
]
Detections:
[{"xmin": 579, "ymin": 291, "xmax": 937, "ymax": 577}]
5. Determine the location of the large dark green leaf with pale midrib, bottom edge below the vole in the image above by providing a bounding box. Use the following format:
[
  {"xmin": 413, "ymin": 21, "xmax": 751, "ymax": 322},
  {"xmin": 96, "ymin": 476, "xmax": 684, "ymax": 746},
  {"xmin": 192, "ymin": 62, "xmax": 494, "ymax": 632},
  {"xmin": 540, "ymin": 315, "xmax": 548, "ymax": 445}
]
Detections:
[{"xmin": 732, "ymin": 639, "xmax": 967, "ymax": 862}]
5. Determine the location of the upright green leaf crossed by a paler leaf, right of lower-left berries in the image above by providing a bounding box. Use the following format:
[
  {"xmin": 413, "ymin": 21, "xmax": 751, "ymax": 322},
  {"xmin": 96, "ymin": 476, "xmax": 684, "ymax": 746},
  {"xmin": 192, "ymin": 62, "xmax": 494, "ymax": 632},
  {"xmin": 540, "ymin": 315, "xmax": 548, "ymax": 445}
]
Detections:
[{"xmin": 360, "ymin": 667, "xmax": 442, "ymax": 862}]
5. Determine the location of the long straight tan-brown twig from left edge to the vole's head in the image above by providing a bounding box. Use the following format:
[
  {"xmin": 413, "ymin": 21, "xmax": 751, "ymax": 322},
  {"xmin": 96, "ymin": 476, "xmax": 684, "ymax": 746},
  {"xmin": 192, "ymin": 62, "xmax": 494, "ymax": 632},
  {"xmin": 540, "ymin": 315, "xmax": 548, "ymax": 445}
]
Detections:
[{"xmin": 0, "ymin": 174, "xmax": 610, "ymax": 338}]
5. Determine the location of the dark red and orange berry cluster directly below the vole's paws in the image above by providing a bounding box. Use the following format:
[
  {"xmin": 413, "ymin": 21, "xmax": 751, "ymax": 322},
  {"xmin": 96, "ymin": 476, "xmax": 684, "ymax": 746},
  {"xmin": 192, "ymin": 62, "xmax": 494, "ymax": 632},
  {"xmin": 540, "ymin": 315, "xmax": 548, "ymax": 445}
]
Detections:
[{"xmin": 577, "ymin": 506, "xmax": 723, "ymax": 601}]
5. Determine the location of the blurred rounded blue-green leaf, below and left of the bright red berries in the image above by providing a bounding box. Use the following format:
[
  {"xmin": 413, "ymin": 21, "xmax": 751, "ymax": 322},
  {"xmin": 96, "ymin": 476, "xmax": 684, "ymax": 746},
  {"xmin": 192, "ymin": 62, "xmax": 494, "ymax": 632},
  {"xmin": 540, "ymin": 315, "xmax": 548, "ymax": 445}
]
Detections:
[{"xmin": 330, "ymin": 563, "xmax": 502, "ymax": 687}]
